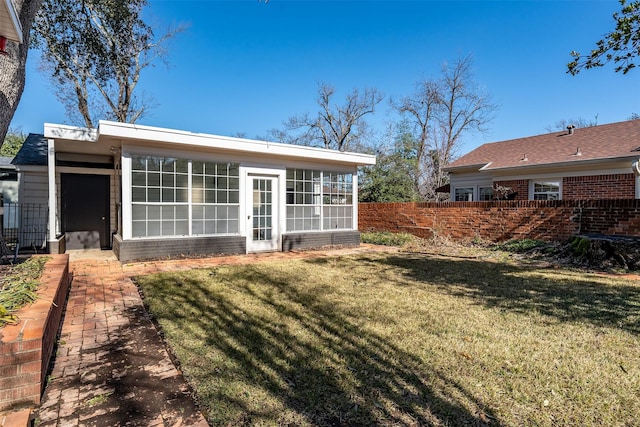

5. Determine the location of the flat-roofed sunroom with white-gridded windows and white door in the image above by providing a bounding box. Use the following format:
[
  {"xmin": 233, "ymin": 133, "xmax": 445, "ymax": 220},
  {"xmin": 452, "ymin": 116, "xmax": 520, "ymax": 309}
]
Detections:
[{"xmin": 36, "ymin": 121, "xmax": 375, "ymax": 261}]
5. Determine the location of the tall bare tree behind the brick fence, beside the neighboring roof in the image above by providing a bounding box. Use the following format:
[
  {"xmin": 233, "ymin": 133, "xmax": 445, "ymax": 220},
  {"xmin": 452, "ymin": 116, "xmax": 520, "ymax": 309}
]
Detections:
[{"xmin": 391, "ymin": 56, "xmax": 497, "ymax": 200}]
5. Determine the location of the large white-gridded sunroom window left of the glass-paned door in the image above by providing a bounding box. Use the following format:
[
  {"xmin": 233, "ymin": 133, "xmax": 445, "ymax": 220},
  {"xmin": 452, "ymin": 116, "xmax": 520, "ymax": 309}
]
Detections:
[{"xmin": 131, "ymin": 156, "xmax": 239, "ymax": 237}]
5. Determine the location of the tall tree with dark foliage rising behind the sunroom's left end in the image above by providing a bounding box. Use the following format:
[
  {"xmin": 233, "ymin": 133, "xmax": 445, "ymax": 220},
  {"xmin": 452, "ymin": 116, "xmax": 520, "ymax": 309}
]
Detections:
[{"xmin": 34, "ymin": 0, "xmax": 180, "ymax": 128}]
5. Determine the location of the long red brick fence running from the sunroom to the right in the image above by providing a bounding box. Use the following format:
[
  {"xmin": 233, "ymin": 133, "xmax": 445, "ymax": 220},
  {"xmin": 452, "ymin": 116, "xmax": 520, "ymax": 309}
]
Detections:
[{"xmin": 358, "ymin": 200, "xmax": 640, "ymax": 242}]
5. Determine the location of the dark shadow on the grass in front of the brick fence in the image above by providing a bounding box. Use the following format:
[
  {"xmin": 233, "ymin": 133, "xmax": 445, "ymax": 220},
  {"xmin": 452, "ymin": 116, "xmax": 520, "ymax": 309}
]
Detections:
[{"xmin": 372, "ymin": 254, "xmax": 640, "ymax": 334}]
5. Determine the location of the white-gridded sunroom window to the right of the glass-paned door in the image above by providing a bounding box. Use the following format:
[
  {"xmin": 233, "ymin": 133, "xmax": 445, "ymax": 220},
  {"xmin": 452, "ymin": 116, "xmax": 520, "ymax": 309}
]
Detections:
[{"xmin": 287, "ymin": 169, "xmax": 353, "ymax": 231}]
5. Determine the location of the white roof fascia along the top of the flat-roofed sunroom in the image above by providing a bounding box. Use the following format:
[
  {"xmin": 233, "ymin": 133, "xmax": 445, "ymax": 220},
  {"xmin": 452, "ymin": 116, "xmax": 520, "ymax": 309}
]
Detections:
[{"xmin": 44, "ymin": 120, "xmax": 376, "ymax": 165}]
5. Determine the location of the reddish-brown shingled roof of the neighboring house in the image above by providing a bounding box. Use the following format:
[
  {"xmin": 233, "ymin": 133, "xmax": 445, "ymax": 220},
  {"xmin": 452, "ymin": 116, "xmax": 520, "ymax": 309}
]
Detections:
[{"xmin": 445, "ymin": 120, "xmax": 640, "ymax": 170}]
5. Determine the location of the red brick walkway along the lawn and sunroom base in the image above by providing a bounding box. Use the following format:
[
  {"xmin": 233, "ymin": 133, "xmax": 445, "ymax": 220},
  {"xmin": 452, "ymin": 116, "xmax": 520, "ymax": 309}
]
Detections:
[{"xmin": 36, "ymin": 245, "xmax": 393, "ymax": 427}]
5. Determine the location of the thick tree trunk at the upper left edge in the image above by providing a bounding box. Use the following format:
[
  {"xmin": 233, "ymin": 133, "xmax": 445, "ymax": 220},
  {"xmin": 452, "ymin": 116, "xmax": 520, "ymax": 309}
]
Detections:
[{"xmin": 0, "ymin": 0, "xmax": 42, "ymax": 146}]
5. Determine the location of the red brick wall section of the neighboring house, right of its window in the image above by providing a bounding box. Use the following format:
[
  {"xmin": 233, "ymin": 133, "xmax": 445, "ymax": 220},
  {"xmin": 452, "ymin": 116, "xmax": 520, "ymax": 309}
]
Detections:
[{"xmin": 562, "ymin": 173, "xmax": 636, "ymax": 200}]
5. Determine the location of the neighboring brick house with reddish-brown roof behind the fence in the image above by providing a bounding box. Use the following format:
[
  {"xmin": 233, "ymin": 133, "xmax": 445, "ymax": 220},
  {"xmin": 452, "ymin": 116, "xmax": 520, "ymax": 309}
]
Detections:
[{"xmin": 445, "ymin": 120, "xmax": 640, "ymax": 201}]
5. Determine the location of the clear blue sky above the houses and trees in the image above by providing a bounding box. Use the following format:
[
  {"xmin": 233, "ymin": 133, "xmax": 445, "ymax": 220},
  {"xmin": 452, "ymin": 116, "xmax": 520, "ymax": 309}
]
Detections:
[{"xmin": 12, "ymin": 0, "xmax": 640, "ymax": 153}]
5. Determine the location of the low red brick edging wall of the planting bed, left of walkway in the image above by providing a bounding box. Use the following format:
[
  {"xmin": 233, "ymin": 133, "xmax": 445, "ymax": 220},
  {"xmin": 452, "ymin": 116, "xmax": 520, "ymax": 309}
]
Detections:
[{"xmin": 0, "ymin": 254, "xmax": 70, "ymax": 412}]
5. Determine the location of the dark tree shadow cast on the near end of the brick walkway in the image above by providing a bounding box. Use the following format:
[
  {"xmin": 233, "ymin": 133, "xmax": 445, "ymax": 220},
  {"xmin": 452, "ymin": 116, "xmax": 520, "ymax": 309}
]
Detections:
[{"xmin": 39, "ymin": 306, "xmax": 199, "ymax": 426}]
